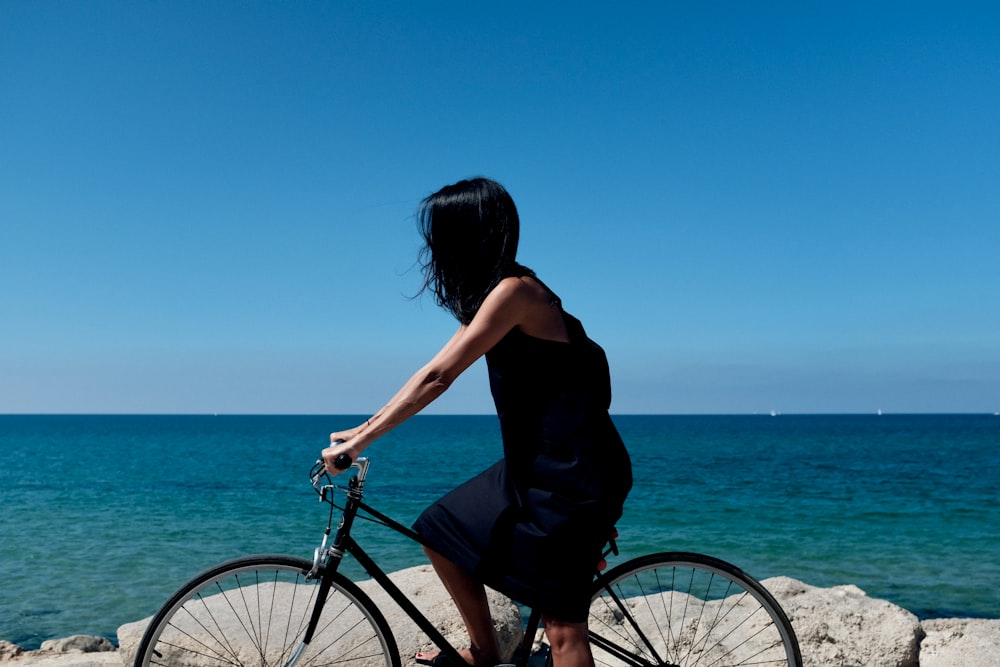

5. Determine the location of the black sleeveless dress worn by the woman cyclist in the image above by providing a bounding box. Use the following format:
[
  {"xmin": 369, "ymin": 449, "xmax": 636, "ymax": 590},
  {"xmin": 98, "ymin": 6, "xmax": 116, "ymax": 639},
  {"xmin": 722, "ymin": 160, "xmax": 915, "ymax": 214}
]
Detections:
[{"xmin": 413, "ymin": 295, "xmax": 632, "ymax": 622}]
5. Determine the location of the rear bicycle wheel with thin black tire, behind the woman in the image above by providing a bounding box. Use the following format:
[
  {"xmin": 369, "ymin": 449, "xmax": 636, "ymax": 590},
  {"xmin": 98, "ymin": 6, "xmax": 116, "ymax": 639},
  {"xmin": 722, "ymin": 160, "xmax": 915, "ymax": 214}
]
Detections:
[{"xmin": 588, "ymin": 553, "xmax": 802, "ymax": 667}]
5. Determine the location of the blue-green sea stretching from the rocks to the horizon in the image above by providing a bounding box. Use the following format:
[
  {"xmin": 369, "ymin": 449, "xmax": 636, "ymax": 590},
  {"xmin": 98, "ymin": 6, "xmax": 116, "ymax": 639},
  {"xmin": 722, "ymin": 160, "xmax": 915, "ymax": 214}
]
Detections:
[{"xmin": 0, "ymin": 414, "xmax": 1000, "ymax": 649}]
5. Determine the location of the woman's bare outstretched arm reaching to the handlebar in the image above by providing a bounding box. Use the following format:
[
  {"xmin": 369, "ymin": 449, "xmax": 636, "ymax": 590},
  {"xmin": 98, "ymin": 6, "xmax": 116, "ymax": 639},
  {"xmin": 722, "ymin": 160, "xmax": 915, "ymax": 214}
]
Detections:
[{"xmin": 323, "ymin": 279, "xmax": 534, "ymax": 474}]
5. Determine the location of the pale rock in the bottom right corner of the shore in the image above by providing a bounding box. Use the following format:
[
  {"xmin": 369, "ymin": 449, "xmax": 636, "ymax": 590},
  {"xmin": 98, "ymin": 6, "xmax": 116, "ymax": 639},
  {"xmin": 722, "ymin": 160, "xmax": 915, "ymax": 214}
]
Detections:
[{"xmin": 920, "ymin": 618, "xmax": 1000, "ymax": 667}]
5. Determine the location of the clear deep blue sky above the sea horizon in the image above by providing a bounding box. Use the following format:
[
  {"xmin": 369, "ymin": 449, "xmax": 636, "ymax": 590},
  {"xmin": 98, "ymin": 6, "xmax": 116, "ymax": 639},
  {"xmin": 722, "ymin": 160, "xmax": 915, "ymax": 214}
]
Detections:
[{"xmin": 0, "ymin": 1, "xmax": 1000, "ymax": 414}]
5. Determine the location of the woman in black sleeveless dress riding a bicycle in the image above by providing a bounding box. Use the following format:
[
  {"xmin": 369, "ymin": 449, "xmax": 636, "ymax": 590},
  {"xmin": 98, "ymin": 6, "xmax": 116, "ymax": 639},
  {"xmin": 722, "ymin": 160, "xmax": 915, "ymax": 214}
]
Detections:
[{"xmin": 323, "ymin": 178, "xmax": 632, "ymax": 667}]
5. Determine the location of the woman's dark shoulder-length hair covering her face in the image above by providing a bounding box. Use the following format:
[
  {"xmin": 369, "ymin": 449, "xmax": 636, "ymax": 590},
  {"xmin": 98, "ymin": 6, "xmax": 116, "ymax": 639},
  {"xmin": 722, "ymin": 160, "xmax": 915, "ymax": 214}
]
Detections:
[{"xmin": 417, "ymin": 178, "xmax": 531, "ymax": 324}]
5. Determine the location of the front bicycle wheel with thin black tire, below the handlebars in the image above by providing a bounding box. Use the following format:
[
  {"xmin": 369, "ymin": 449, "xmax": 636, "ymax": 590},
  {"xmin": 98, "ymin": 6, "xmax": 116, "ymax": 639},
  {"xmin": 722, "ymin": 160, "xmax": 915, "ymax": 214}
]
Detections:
[{"xmin": 134, "ymin": 555, "xmax": 400, "ymax": 667}]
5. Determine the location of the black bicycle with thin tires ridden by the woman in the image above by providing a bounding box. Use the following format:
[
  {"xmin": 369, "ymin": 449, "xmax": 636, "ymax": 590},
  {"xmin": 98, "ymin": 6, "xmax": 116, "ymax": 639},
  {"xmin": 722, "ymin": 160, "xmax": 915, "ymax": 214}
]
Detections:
[{"xmin": 135, "ymin": 458, "xmax": 802, "ymax": 667}]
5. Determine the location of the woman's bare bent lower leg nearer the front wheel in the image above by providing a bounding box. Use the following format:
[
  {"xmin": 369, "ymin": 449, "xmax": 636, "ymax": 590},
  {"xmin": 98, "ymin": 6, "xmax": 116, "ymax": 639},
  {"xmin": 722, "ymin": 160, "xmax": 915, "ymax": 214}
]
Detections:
[{"xmin": 424, "ymin": 547, "xmax": 500, "ymax": 665}]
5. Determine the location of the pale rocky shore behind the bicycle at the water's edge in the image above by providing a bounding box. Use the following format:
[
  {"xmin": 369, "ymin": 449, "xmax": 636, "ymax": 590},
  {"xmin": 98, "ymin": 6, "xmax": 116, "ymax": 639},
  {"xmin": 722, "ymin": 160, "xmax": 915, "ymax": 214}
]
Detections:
[{"xmin": 0, "ymin": 566, "xmax": 1000, "ymax": 667}]
